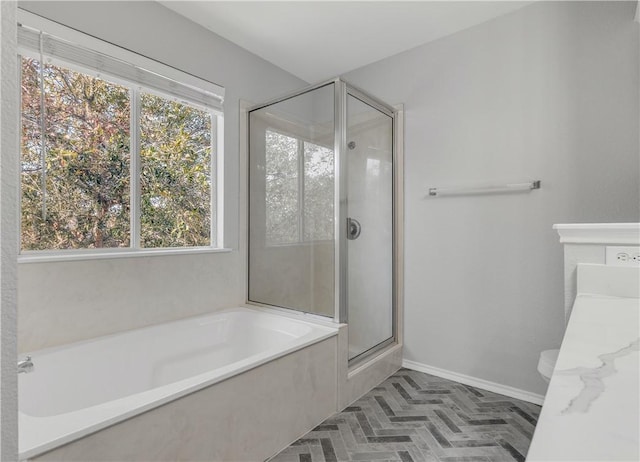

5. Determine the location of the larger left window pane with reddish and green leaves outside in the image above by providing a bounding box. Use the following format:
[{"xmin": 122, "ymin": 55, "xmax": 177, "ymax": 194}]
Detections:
[{"xmin": 21, "ymin": 58, "xmax": 130, "ymax": 250}]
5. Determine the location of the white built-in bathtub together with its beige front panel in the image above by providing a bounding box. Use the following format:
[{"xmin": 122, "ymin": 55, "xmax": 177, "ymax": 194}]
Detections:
[{"xmin": 19, "ymin": 308, "xmax": 337, "ymax": 460}]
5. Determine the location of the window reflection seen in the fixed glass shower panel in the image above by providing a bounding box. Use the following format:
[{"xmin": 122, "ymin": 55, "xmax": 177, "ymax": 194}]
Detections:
[{"xmin": 265, "ymin": 130, "xmax": 334, "ymax": 245}]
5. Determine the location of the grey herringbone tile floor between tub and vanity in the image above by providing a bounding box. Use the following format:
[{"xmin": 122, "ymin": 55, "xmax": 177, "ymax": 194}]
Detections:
[{"xmin": 270, "ymin": 369, "xmax": 540, "ymax": 462}]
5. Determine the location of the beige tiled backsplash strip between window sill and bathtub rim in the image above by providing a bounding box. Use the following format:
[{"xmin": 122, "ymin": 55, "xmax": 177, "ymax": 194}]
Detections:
[{"xmin": 18, "ymin": 251, "xmax": 243, "ymax": 353}]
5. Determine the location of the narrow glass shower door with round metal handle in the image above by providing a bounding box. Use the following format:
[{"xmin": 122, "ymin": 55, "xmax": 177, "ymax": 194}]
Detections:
[{"xmin": 345, "ymin": 93, "xmax": 394, "ymax": 360}]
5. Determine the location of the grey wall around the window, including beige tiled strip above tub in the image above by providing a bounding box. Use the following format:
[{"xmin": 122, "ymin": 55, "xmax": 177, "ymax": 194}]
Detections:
[{"xmin": 18, "ymin": 1, "xmax": 306, "ymax": 351}]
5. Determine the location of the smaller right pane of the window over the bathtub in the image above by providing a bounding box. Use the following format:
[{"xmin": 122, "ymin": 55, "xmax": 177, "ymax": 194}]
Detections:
[{"xmin": 140, "ymin": 93, "xmax": 212, "ymax": 247}]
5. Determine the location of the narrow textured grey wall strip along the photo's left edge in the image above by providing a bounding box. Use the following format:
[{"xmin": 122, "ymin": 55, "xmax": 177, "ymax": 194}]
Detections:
[{"xmin": 0, "ymin": 2, "xmax": 19, "ymax": 460}]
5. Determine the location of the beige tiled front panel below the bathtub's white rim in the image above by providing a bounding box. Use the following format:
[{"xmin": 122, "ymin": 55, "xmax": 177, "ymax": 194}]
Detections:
[{"xmin": 33, "ymin": 337, "xmax": 336, "ymax": 462}]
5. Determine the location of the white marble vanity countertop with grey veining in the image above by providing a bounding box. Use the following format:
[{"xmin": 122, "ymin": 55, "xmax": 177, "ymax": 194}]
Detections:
[{"xmin": 527, "ymin": 290, "xmax": 640, "ymax": 462}]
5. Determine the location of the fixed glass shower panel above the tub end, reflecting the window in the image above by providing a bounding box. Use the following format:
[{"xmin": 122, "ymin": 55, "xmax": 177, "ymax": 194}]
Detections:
[{"xmin": 248, "ymin": 83, "xmax": 335, "ymax": 318}]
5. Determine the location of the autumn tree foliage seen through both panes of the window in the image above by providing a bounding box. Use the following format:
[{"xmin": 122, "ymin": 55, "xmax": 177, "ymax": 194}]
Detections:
[{"xmin": 21, "ymin": 59, "xmax": 211, "ymax": 250}]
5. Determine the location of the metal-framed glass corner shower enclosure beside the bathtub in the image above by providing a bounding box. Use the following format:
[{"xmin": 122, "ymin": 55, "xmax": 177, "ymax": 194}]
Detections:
[{"xmin": 248, "ymin": 79, "xmax": 399, "ymax": 362}]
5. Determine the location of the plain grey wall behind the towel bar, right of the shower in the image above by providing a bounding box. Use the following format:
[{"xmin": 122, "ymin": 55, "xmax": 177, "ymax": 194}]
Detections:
[{"xmin": 345, "ymin": 2, "xmax": 639, "ymax": 393}]
